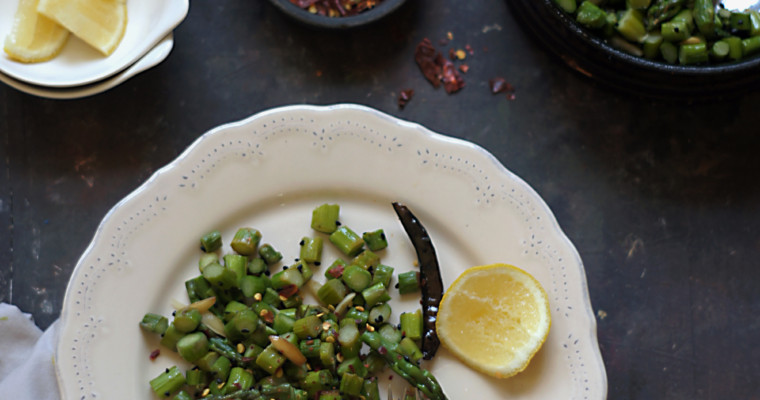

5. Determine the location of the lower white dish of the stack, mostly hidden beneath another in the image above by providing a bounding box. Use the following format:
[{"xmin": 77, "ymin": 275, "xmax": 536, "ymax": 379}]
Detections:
[{"xmin": 0, "ymin": 33, "xmax": 174, "ymax": 99}]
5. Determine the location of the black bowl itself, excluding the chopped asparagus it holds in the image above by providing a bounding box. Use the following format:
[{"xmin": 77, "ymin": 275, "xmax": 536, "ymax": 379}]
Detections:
[{"xmin": 507, "ymin": 0, "xmax": 760, "ymax": 100}]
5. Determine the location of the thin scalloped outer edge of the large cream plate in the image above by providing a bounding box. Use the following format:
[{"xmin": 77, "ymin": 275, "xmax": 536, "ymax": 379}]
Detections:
[{"xmin": 55, "ymin": 103, "xmax": 608, "ymax": 399}]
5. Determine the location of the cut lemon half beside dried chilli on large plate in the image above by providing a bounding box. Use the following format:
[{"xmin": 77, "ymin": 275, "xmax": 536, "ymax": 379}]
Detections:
[{"xmin": 436, "ymin": 264, "xmax": 551, "ymax": 378}]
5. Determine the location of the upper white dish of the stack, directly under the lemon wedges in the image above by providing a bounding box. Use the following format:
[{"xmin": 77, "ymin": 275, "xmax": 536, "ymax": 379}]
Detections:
[{"xmin": 0, "ymin": 0, "xmax": 189, "ymax": 88}]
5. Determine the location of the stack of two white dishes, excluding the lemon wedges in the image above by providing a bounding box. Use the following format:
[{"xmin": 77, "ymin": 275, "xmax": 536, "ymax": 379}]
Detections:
[{"xmin": 0, "ymin": 0, "xmax": 189, "ymax": 99}]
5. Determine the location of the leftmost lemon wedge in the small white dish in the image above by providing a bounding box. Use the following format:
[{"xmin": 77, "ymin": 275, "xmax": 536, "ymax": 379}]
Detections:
[{"xmin": 4, "ymin": 0, "xmax": 69, "ymax": 63}]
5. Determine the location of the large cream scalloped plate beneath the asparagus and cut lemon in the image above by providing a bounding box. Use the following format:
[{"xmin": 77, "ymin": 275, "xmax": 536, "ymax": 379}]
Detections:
[{"xmin": 56, "ymin": 105, "xmax": 607, "ymax": 400}]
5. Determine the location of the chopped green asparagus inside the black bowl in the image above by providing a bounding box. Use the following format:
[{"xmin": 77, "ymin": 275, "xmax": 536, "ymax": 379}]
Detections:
[{"xmin": 555, "ymin": 0, "xmax": 760, "ymax": 65}]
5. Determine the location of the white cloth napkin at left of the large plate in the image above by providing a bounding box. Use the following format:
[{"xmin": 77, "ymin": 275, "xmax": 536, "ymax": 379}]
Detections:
[{"xmin": 0, "ymin": 303, "xmax": 60, "ymax": 400}]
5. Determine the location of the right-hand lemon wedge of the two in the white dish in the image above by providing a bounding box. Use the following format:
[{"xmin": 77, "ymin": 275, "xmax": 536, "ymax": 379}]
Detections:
[{"xmin": 37, "ymin": 0, "xmax": 127, "ymax": 56}]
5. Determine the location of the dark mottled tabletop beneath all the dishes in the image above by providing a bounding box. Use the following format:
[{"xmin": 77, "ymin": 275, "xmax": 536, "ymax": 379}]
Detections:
[{"xmin": 0, "ymin": 0, "xmax": 760, "ymax": 399}]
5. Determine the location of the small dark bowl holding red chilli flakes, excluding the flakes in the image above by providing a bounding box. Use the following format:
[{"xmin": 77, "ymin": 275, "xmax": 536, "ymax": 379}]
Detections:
[{"xmin": 269, "ymin": 0, "xmax": 406, "ymax": 29}]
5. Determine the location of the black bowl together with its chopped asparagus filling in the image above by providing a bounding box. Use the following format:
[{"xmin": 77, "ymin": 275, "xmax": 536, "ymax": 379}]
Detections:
[{"xmin": 509, "ymin": 0, "xmax": 760, "ymax": 99}]
